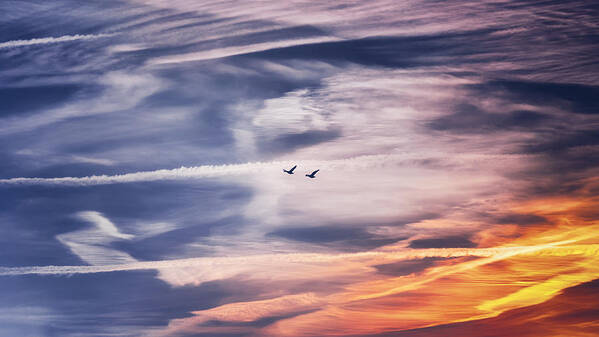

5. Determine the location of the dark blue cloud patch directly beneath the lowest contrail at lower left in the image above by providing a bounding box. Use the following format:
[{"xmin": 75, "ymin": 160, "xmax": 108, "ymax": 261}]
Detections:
[{"xmin": 0, "ymin": 271, "xmax": 236, "ymax": 336}]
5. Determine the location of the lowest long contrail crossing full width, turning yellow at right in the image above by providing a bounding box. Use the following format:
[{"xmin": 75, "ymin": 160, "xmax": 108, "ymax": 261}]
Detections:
[{"xmin": 0, "ymin": 245, "xmax": 599, "ymax": 276}]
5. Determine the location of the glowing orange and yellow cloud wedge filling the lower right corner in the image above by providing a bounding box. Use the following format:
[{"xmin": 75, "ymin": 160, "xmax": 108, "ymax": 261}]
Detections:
[{"xmin": 265, "ymin": 198, "xmax": 599, "ymax": 336}]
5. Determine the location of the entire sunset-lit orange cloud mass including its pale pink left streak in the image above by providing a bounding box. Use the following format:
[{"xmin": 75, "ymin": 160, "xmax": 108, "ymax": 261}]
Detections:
[{"xmin": 127, "ymin": 189, "xmax": 599, "ymax": 337}]
